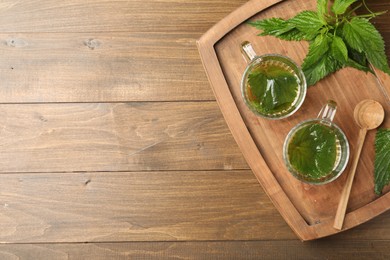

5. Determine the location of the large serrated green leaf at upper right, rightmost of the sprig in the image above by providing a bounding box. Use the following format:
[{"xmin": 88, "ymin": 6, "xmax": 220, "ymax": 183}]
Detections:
[{"xmin": 342, "ymin": 17, "xmax": 390, "ymax": 74}]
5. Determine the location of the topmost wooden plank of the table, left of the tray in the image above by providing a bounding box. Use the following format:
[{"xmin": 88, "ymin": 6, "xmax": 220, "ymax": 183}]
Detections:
[{"xmin": 0, "ymin": 0, "xmax": 247, "ymax": 35}]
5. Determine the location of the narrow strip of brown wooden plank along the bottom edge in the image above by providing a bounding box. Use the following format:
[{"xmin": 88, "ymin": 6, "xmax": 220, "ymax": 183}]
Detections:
[{"xmin": 0, "ymin": 240, "xmax": 390, "ymax": 260}]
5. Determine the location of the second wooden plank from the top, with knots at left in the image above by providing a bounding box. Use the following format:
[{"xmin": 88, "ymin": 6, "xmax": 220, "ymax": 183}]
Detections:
[{"xmin": 0, "ymin": 33, "xmax": 215, "ymax": 103}]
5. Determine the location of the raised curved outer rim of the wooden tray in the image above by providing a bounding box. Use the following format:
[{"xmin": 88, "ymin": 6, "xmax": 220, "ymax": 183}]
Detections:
[{"xmin": 197, "ymin": 0, "xmax": 390, "ymax": 241}]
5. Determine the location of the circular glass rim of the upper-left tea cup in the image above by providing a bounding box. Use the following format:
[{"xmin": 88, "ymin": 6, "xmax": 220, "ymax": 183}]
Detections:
[{"xmin": 241, "ymin": 53, "xmax": 307, "ymax": 120}]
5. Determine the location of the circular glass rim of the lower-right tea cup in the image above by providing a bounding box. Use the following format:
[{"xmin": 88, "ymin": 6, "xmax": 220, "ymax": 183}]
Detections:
[{"xmin": 283, "ymin": 118, "xmax": 350, "ymax": 186}]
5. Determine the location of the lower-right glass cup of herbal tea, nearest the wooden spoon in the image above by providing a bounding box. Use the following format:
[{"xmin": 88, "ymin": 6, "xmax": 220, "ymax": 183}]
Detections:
[{"xmin": 283, "ymin": 100, "xmax": 349, "ymax": 185}]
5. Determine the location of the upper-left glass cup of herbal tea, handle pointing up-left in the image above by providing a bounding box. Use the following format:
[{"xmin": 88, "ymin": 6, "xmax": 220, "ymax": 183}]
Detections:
[{"xmin": 241, "ymin": 41, "xmax": 307, "ymax": 119}]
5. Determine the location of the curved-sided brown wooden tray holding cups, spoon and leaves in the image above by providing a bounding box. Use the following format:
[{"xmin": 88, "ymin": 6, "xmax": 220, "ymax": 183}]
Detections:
[{"xmin": 197, "ymin": 0, "xmax": 390, "ymax": 240}]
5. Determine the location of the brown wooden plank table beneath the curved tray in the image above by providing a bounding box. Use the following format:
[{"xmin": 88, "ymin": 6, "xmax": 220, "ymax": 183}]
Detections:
[{"xmin": 0, "ymin": 0, "xmax": 390, "ymax": 259}]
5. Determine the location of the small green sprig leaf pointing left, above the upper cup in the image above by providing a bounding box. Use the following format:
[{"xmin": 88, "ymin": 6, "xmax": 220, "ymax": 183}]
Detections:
[{"xmin": 287, "ymin": 11, "xmax": 324, "ymax": 35}]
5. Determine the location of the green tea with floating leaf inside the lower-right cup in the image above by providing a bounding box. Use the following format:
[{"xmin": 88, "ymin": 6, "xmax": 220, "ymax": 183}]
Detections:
[{"xmin": 287, "ymin": 122, "xmax": 341, "ymax": 180}]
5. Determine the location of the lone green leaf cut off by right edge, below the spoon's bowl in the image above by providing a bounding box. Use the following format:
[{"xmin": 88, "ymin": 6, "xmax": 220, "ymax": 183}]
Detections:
[{"xmin": 374, "ymin": 128, "xmax": 390, "ymax": 195}]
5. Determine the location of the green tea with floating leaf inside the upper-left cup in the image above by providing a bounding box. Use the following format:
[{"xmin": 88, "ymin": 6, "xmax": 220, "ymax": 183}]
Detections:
[{"xmin": 245, "ymin": 60, "xmax": 301, "ymax": 115}]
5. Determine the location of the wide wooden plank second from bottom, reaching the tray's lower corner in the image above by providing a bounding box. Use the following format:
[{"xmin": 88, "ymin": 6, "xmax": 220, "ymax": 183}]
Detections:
[{"xmin": 0, "ymin": 170, "xmax": 295, "ymax": 243}]
